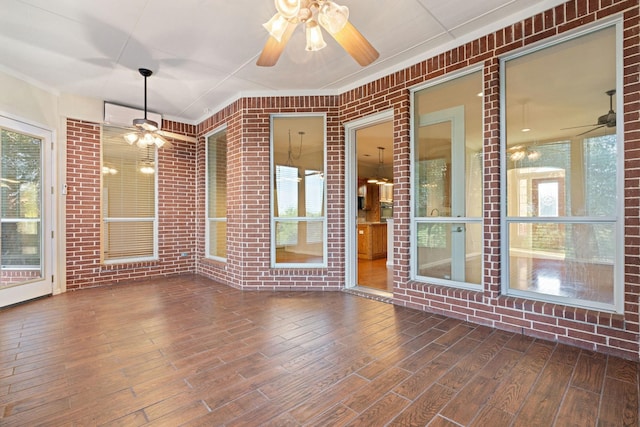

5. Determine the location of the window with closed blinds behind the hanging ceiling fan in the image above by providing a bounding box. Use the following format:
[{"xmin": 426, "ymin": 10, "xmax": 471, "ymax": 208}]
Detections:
[{"xmin": 102, "ymin": 126, "xmax": 158, "ymax": 263}]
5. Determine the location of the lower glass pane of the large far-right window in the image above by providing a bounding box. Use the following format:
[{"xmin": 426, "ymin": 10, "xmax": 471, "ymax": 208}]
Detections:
[{"xmin": 509, "ymin": 223, "xmax": 616, "ymax": 304}]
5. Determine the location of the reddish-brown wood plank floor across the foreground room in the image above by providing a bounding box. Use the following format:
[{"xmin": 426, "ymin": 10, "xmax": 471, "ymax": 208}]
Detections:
[{"xmin": 0, "ymin": 275, "xmax": 639, "ymax": 426}]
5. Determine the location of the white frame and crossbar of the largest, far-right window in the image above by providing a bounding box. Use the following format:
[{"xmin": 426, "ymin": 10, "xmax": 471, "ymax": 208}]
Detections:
[{"xmin": 500, "ymin": 17, "xmax": 625, "ymax": 313}]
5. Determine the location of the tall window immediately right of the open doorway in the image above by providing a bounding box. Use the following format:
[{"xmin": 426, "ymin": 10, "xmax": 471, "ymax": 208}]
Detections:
[{"xmin": 411, "ymin": 71, "xmax": 483, "ymax": 289}]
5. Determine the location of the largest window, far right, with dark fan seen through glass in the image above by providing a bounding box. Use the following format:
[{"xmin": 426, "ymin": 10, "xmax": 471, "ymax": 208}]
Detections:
[{"xmin": 502, "ymin": 25, "xmax": 623, "ymax": 310}]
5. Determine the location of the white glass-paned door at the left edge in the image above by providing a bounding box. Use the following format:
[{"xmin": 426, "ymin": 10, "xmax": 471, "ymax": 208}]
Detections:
[{"xmin": 0, "ymin": 116, "xmax": 53, "ymax": 307}]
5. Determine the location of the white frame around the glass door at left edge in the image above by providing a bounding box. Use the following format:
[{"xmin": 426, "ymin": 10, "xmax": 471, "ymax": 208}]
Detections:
[{"xmin": 0, "ymin": 112, "xmax": 57, "ymax": 307}]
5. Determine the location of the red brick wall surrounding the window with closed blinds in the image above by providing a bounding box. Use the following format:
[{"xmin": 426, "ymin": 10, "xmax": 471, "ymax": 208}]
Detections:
[{"xmin": 65, "ymin": 119, "xmax": 196, "ymax": 290}]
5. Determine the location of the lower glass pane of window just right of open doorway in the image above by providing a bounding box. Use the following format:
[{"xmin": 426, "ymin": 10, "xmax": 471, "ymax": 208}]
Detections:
[{"xmin": 417, "ymin": 222, "xmax": 482, "ymax": 285}]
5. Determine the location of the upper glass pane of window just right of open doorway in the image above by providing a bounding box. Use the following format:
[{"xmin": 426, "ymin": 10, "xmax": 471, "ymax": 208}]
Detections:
[{"xmin": 413, "ymin": 72, "xmax": 483, "ymax": 218}]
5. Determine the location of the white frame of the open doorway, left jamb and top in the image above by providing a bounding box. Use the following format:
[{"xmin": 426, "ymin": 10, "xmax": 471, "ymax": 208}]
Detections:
[{"xmin": 344, "ymin": 109, "xmax": 394, "ymax": 289}]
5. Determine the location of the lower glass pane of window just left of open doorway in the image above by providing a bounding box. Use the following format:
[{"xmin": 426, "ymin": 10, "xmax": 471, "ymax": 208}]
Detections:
[{"xmin": 276, "ymin": 221, "xmax": 324, "ymax": 264}]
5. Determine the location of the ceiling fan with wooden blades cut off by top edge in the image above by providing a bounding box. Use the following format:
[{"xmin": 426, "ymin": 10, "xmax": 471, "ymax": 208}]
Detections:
[{"xmin": 256, "ymin": 0, "xmax": 380, "ymax": 67}]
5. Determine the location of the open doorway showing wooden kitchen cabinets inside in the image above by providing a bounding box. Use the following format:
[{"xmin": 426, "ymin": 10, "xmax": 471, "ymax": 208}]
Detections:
[{"xmin": 345, "ymin": 110, "xmax": 394, "ymax": 295}]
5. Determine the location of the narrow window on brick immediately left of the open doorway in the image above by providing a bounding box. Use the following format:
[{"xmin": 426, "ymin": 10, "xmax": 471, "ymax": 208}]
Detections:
[{"xmin": 271, "ymin": 115, "xmax": 326, "ymax": 267}]
